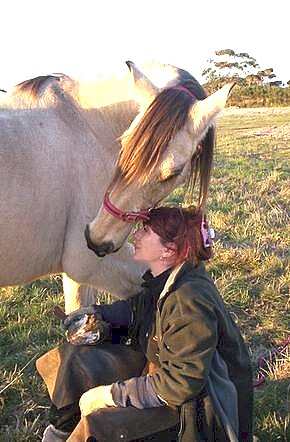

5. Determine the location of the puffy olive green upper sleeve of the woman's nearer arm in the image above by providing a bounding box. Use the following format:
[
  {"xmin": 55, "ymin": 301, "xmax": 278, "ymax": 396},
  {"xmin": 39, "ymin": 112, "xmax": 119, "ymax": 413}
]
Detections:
[{"xmin": 152, "ymin": 289, "xmax": 217, "ymax": 406}]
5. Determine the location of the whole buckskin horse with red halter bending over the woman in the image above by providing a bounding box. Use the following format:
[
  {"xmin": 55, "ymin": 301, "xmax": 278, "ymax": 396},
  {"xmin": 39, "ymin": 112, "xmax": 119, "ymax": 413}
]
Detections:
[{"xmin": 0, "ymin": 62, "xmax": 232, "ymax": 313}]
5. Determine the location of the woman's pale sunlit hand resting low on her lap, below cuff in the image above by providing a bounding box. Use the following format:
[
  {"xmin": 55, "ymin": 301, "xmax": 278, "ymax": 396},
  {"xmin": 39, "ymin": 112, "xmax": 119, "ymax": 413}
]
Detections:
[{"xmin": 79, "ymin": 385, "xmax": 117, "ymax": 416}]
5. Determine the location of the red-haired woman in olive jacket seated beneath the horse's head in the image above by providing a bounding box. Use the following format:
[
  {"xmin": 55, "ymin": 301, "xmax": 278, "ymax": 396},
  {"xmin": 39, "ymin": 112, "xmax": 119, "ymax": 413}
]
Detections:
[{"xmin": 38, "ymin": 207, "xmax": 253, "ymax": 442}]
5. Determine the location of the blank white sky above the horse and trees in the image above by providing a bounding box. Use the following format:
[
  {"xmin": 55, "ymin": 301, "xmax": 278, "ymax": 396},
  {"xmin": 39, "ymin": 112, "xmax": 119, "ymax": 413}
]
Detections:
[{"xmin": 0, "ymin": 0, "xmax": 290, "ymax": 90}]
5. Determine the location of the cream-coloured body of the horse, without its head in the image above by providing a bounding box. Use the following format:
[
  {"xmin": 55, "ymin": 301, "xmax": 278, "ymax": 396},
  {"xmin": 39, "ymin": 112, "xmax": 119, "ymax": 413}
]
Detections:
[{"xmin": 0, "ymin": 68, "xmax": 144, "ymax": 311}]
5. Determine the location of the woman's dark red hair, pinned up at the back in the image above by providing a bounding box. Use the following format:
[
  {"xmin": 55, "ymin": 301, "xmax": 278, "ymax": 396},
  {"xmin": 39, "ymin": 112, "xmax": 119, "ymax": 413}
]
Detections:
[{"xmin": 145, "ymin": 207, "xmax": 212, "ymax": 265}]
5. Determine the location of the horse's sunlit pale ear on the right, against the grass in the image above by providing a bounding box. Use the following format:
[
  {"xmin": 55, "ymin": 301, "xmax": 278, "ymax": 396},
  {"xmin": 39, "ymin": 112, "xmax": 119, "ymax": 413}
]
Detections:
[{"xmin": 190, "ymin": 83, "xmax": 235, "ymax": 135}]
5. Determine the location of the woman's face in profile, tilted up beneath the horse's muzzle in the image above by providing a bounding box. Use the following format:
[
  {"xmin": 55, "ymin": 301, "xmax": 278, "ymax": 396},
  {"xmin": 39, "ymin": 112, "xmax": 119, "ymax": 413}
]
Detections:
[{"xmin": 133, "ymin": 225, "xmax": 167, "ymax": 267}]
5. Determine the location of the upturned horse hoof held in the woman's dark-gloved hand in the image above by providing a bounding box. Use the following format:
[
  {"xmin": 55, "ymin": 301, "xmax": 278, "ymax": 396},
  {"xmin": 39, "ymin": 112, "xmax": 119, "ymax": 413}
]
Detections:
[{"xmin": 63, "ymin": 305, "xmax": 111, "ymax": 345}]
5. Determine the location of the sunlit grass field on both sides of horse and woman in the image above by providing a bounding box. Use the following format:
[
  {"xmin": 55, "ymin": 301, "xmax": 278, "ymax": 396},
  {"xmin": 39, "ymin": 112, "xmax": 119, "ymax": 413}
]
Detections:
[{"xmin": 0, "ymin": 108, "xmax": 290, "ymax": 442}]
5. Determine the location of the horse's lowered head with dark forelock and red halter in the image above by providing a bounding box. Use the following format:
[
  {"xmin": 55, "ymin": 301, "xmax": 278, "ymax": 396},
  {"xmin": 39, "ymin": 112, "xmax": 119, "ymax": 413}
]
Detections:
[{"xmin": 85, "ymin": 62, "xmax": 233, "ymax": 257}]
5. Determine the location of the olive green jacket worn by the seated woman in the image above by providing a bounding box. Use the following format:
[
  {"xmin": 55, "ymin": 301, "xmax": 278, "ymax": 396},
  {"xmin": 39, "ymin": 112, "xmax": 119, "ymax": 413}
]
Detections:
[{"xmin": 132, "ymin": 263, "xmax": 253, "ymax": 441}]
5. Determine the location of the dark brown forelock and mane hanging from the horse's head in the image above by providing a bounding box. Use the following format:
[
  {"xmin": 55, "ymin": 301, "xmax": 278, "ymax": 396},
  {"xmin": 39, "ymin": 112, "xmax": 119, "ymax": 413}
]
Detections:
[{"xmin": 112, "ymin": 69, "xmax": 215, "ymax": 206}]
